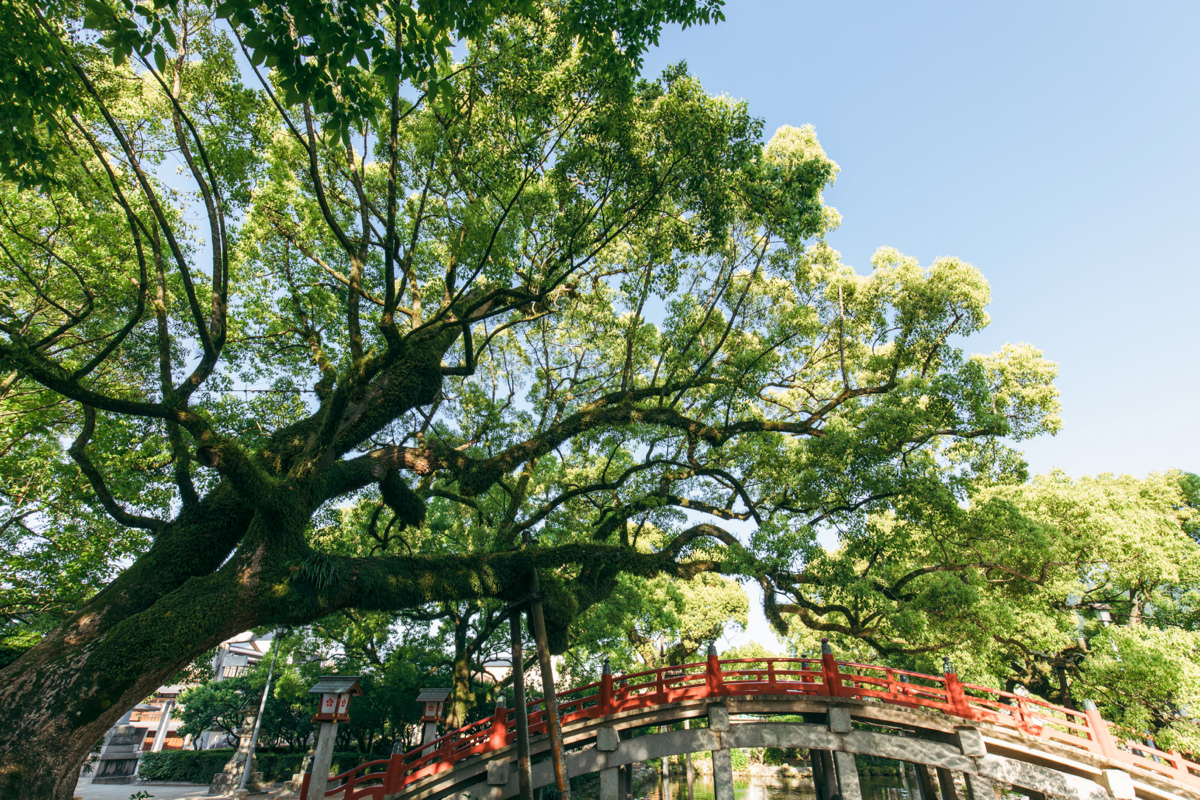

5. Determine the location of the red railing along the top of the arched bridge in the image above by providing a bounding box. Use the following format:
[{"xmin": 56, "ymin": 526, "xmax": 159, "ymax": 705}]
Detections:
[{"xmin": 301, "ymin": 654, "xmax": 1200, "ymax": 800}]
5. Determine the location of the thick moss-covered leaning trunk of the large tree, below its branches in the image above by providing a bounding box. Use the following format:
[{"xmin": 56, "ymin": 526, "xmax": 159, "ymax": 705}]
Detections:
[{"xmin": 0, "ymin": 489, "xmax": 267, "ymax": 800}]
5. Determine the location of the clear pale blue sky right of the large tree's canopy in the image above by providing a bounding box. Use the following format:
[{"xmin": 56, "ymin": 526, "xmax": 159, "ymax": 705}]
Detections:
[{"xmin": 646, "ymin": 0, "xmax": 1200, "ymax": 477}]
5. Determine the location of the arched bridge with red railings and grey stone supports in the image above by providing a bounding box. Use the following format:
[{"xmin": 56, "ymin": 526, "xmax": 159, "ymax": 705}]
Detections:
[{"xmin": 301, "ymin": 652, "xmax": 1200, "ymax": 800}]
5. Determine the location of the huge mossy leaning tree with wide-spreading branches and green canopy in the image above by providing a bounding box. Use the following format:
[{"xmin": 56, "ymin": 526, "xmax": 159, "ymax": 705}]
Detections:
[{"xmin": 0, "ymin": 0, "xmax": 1056, "ymax": 798}]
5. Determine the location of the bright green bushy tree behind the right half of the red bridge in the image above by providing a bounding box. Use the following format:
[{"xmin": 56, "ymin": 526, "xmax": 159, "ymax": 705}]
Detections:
[{"xmin": 776, "ymin": 473, "xmax": 1200, "ymax": 752}]
